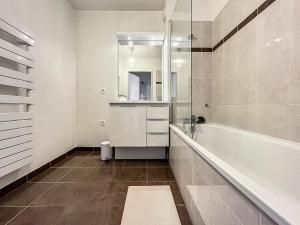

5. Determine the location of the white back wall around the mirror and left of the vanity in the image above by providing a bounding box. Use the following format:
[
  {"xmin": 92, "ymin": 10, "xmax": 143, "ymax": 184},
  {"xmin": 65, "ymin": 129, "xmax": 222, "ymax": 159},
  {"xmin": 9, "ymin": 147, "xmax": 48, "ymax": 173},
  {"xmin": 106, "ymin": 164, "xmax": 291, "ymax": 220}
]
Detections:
[{"xmin": 76, "ymin": 11, "xmax": 164, "ymax": 146}]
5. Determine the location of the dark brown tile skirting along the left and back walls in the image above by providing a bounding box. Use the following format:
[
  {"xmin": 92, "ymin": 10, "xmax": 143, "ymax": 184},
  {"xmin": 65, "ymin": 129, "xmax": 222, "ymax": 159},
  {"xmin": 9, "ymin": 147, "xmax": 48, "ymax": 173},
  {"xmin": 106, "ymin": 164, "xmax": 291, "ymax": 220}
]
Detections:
[{"xmin": 0, "ymin": 147, "xmax": 101, "ymax": 198}]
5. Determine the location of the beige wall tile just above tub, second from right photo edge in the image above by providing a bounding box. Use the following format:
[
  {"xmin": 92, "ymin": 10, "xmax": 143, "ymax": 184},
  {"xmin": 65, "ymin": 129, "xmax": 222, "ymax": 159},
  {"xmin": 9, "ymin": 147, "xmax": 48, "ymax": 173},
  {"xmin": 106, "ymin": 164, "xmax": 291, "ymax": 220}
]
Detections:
[{"xmin": 257, "ymin": 105, "xmax": 289, "ymax": 139}]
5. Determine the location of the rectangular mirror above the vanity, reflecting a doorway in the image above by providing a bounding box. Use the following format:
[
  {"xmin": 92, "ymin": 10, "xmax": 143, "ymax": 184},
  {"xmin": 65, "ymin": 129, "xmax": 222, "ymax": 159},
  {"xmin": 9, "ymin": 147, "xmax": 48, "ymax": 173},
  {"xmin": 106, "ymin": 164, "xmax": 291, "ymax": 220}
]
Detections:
[{"xmin": 117, "ymin": 33, "xmax": 164, "ymax": 101}]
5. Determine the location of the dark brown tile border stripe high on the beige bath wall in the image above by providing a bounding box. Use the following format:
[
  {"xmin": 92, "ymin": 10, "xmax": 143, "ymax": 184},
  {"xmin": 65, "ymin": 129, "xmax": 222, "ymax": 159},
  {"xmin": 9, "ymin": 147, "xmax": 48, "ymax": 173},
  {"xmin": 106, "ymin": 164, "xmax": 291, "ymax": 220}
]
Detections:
[{"xmin": 192, "ymin": 0, "xmax": 276, "ymax": 52}]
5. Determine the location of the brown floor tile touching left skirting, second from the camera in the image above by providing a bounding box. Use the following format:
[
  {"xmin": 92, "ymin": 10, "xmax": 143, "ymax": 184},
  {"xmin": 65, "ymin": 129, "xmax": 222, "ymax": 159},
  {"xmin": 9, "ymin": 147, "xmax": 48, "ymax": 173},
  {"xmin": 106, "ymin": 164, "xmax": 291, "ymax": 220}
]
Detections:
[{"xmin": 30, "ymin": 168, "xmax": 71, "ymax": 182}]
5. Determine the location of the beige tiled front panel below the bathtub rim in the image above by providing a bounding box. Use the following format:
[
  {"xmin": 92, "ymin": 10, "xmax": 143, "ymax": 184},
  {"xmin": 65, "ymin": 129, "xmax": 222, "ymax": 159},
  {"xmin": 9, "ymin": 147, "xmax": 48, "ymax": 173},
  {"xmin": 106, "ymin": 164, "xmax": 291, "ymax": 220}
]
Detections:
[{"xmin": 170, "ymin": 126, "xmax": 284, "ymax": 225}]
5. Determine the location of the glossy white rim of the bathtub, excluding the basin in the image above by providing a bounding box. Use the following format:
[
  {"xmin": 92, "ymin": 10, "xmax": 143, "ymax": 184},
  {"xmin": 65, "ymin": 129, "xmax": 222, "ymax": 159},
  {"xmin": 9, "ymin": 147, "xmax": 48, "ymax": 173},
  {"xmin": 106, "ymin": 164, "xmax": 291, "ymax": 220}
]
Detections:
[{"xmin": 170, "ymin": 124, "xmax": 300, "ymax": 225}]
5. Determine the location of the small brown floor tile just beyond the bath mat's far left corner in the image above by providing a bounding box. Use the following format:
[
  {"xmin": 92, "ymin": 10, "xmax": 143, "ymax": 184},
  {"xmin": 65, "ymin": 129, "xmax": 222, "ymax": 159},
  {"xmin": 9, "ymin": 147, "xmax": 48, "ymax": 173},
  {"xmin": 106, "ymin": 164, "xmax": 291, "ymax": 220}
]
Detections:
[{"xmin": 117, "ymin": 167, "xmax": 147, "ymax": 182}]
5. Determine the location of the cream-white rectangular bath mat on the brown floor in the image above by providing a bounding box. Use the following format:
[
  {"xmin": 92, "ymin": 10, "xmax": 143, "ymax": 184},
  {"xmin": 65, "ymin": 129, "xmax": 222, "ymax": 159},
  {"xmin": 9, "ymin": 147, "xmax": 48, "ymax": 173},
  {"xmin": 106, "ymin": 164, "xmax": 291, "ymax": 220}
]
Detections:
[{"xmin": 121, "ymin": 186, "xmax": 181, "ymax": 225}]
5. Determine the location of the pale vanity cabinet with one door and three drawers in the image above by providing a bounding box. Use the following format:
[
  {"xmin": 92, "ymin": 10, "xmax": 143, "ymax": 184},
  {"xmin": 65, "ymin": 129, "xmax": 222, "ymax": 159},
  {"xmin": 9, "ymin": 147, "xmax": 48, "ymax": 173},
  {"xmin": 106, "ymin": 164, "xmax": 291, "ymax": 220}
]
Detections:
[{"xmin": 110, "ymin": 103, "xmax": 169, "ymax": 147}]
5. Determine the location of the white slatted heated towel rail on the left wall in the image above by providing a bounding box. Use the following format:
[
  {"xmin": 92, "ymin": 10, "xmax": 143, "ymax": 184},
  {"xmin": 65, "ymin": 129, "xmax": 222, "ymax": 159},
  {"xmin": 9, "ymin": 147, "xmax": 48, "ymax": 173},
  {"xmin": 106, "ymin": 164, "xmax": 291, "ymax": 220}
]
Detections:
[{"xmin": 0, "ymin": 19, "xmax": 34, "ymax": 177}]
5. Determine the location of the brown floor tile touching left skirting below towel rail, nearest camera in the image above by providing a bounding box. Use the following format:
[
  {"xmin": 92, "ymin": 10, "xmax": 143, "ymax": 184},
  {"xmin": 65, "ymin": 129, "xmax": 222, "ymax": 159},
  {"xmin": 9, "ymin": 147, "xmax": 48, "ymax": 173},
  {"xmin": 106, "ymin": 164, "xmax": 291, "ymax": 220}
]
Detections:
[{"xmin": 0, "ymin": 183, "xmax": 53, "ymax": 206}]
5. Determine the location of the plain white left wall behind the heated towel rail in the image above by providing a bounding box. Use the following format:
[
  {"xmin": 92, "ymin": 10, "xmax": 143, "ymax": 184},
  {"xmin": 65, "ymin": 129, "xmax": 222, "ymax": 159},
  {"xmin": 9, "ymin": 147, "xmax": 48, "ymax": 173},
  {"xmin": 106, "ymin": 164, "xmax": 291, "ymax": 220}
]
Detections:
[{"xmin": 0, "ymin": 0, "xmax": 76, "ymax": 188}]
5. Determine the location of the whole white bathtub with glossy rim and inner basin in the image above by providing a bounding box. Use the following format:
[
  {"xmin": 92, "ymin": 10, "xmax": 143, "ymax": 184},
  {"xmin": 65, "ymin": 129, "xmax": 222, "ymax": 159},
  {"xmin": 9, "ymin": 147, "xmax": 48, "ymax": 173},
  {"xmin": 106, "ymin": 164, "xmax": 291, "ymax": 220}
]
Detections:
[{"xmin": 171, "ymin": 124, "xmax": 300, "ymax": 225}]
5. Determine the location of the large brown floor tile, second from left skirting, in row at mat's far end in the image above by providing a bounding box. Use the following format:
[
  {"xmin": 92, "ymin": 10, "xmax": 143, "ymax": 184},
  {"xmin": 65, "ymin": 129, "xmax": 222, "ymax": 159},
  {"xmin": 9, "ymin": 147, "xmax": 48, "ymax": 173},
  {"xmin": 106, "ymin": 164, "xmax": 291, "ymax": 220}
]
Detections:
[{"xmin": 32, "ymin": 183, "xmax": 110, "ymax": 208}]
